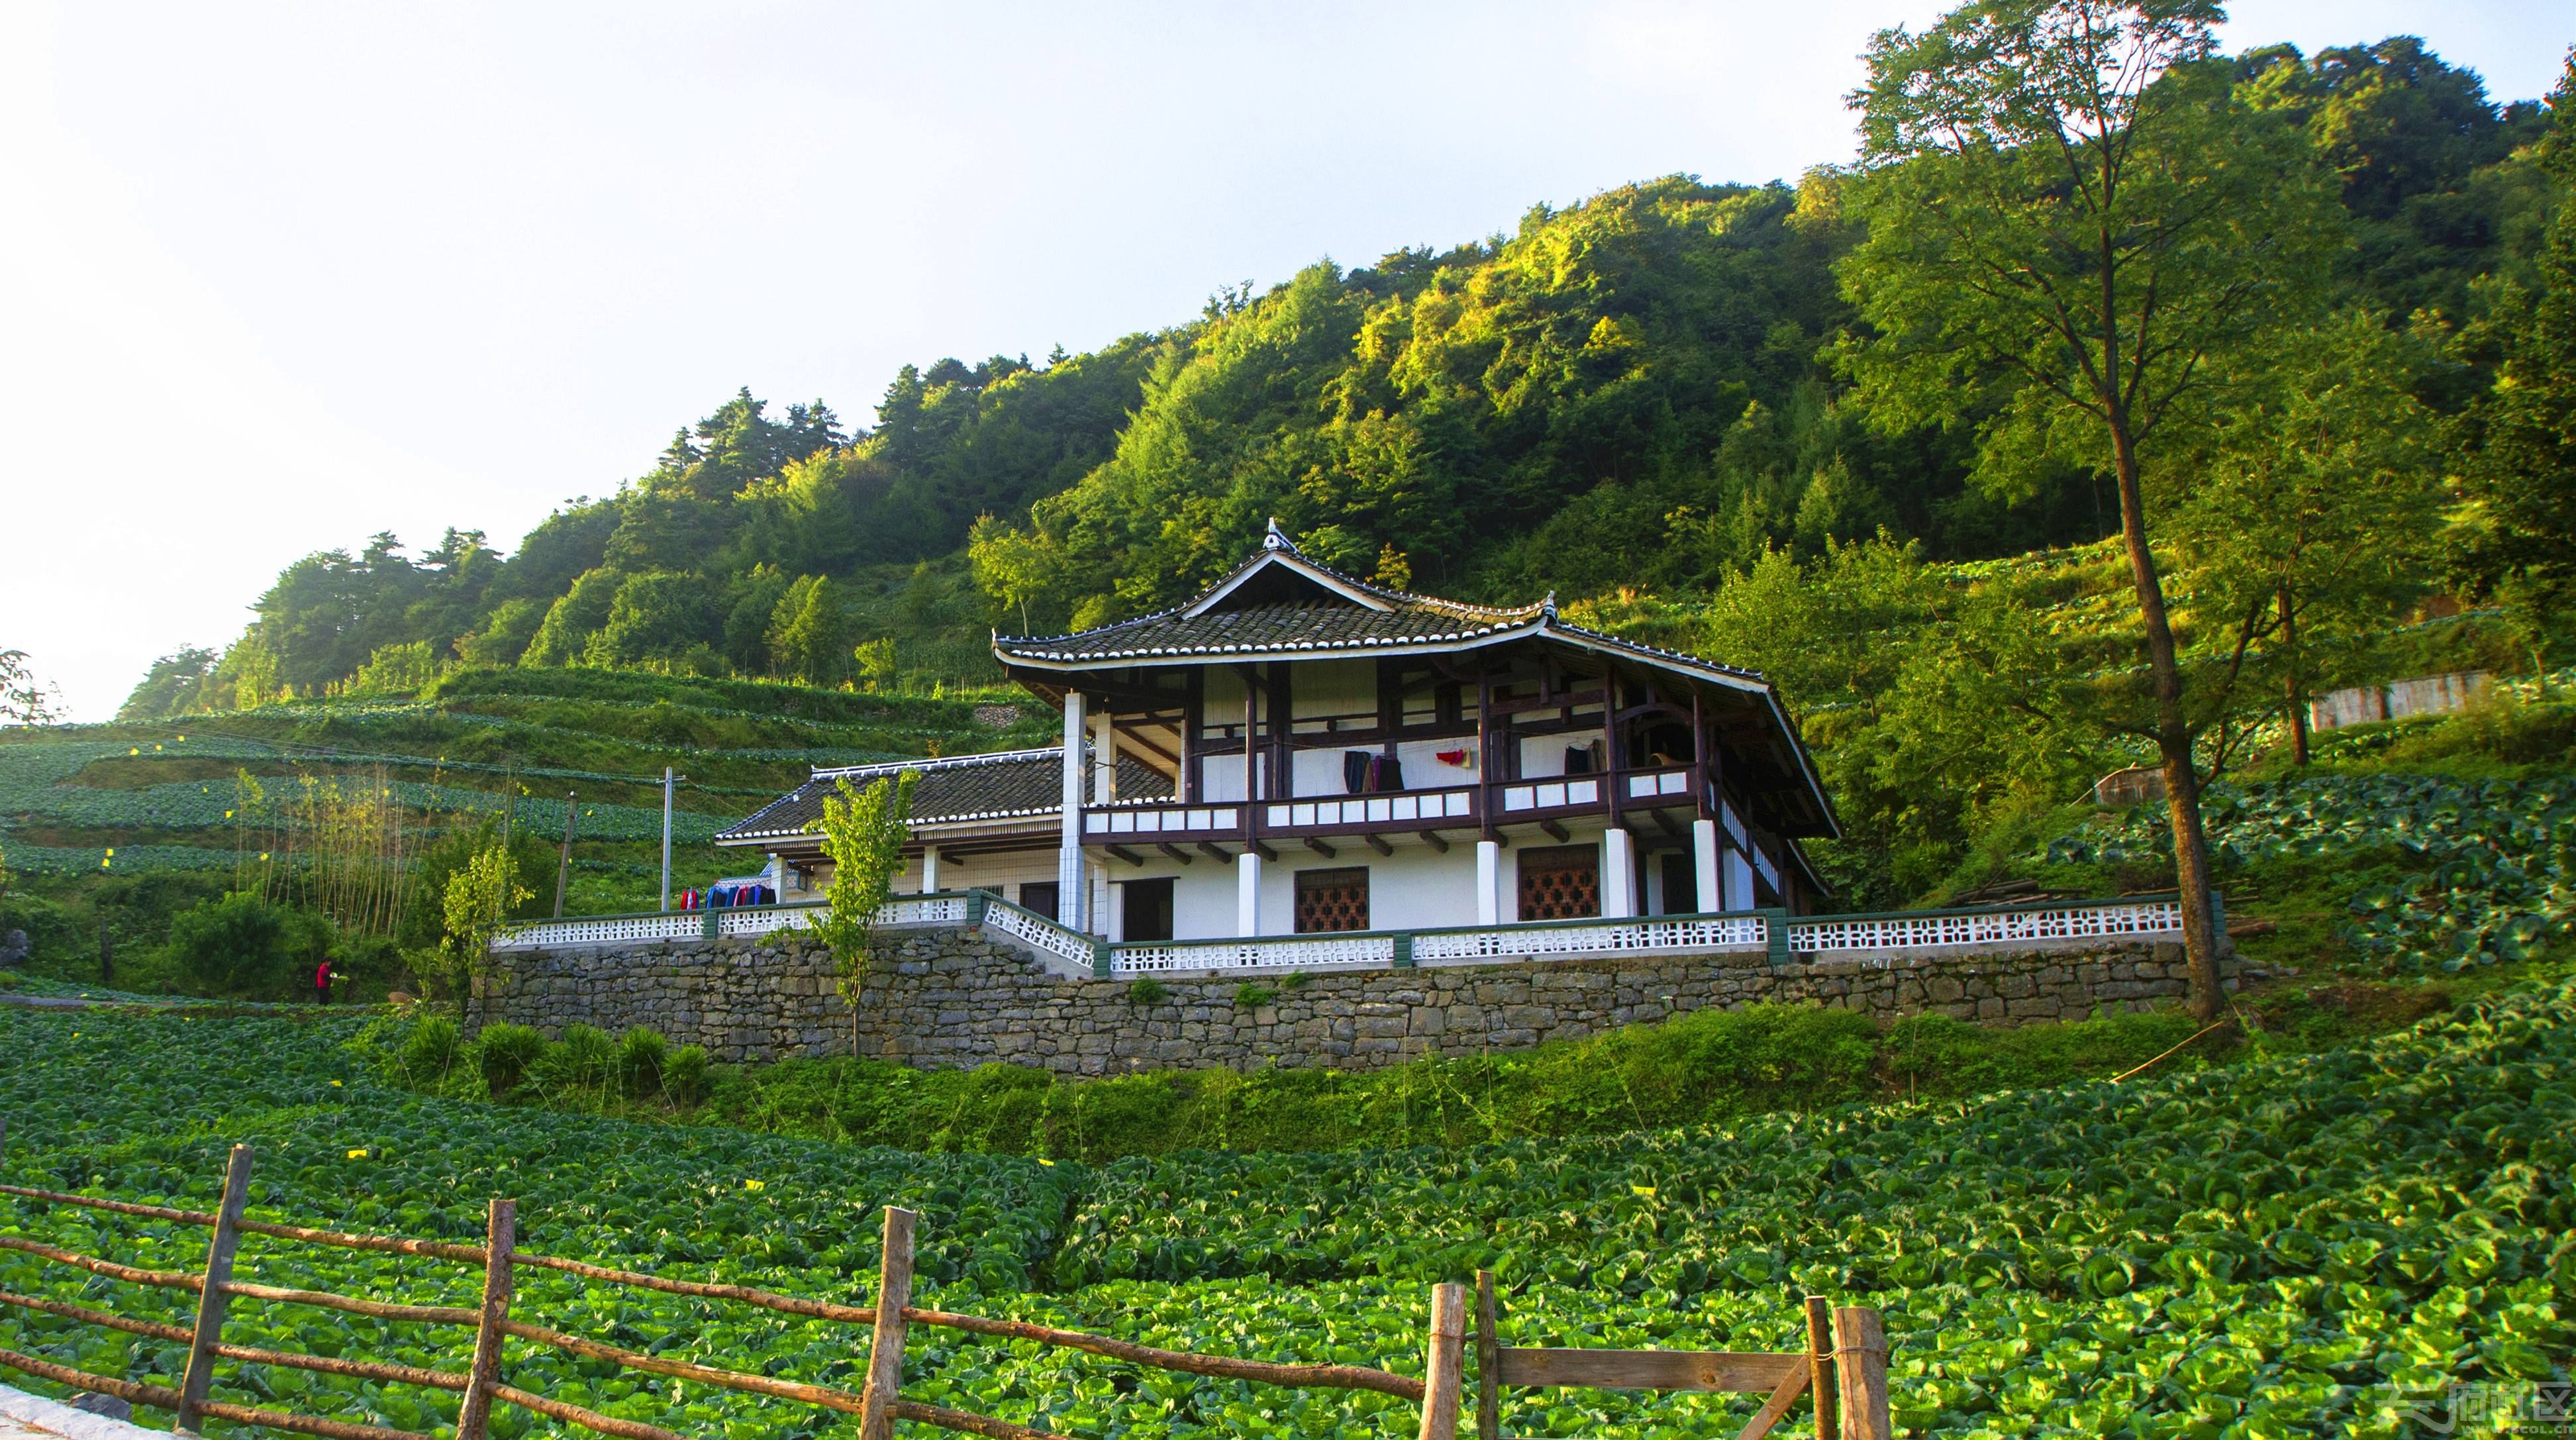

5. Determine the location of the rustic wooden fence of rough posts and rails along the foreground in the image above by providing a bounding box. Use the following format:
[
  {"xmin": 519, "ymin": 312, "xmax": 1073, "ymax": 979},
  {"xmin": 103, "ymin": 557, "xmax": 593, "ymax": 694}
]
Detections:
[{"xmin": 0, "ymin": 1159, "xmax": 1893, "ymax": 1440}]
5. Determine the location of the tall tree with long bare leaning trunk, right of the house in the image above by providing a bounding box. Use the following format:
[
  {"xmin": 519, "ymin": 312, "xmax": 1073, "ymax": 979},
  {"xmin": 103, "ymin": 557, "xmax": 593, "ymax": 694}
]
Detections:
[{"xmin": 1842, "ymin": 0, "xmax": 2336, "ymax": 1017}]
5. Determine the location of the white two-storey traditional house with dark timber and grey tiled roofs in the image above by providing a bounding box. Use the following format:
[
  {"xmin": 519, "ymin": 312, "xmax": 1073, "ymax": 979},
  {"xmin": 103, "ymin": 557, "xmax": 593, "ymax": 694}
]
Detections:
[{"xmin": 718, "ymin": 525, "xmax": 1837, "ymax": 941}]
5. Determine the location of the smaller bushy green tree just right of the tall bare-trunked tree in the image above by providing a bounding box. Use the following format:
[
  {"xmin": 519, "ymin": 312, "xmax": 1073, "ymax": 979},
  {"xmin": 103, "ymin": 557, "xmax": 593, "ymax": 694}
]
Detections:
[{"xmin": 2169, "ymin": 312, "xmax": 2442, "ymax": 765}]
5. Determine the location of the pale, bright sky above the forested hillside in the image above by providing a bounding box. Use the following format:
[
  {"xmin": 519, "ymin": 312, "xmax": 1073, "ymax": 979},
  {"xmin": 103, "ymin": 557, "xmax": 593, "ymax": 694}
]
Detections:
[{"xmin": 0, "ymin": 0, "xmax": 2576, "ymax": 719}]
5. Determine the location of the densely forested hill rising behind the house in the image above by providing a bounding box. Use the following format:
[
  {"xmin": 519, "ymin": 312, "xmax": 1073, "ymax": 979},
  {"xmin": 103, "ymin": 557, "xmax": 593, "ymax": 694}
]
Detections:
[{"xmin": 126, "ymin": 38, "xmax": 2555, "ymax": 719}]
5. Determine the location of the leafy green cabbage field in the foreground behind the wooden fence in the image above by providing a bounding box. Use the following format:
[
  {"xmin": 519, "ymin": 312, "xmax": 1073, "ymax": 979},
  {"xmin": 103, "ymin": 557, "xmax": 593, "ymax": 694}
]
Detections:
[{"xmin": 0, "ymin": 982, "xmax": 2576, "ymax": 1440}]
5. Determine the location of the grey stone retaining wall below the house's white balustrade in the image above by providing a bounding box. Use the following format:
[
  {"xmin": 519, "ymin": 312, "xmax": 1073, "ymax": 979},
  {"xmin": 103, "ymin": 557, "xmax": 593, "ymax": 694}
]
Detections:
[{"xmin": 484, "ymin": 927, "xmax": 2234, "ymax": 1074}]
